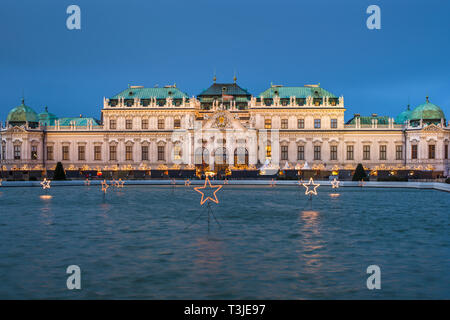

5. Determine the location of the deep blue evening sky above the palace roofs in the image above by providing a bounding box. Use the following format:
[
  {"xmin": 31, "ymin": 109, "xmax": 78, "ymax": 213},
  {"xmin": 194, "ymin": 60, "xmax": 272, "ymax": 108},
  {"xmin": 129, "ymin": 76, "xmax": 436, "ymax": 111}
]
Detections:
[{"xmin": 0, "ymin": 0, "xmax": 450, "ymax": 121}]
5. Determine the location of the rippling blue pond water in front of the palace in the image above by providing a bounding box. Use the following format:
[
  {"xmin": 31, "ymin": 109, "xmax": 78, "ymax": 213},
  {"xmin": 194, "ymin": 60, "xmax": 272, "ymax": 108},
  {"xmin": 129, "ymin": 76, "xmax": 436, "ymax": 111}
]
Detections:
[{"xmin": 0, "ymin": 185, "xmax": 450, "ymax": 299}]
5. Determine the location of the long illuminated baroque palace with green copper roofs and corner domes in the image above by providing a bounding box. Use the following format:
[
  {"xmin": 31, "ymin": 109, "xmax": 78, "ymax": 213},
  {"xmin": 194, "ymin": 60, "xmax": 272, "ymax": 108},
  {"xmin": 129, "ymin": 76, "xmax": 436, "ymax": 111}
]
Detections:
[{"xmin": 0, "ymin": 79, "xmax": 450, "ymax": 176}]
